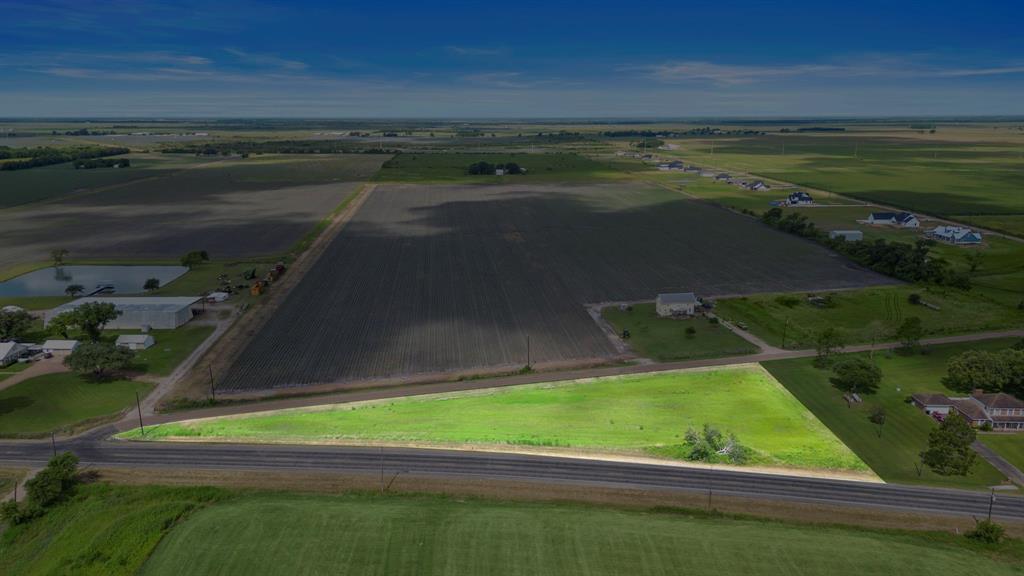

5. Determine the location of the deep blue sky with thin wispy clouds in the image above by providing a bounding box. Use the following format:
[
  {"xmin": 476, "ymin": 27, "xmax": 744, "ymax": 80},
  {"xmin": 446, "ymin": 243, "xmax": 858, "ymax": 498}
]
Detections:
[{"xmin": 0, "ymin": 0, "xmax": 1024, "ymax": 118}]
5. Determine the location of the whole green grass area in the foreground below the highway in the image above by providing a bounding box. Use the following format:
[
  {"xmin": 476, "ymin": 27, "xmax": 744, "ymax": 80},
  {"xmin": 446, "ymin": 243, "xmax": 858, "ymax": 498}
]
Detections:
[{"xmin": 0, "ymin": 484, "xmax": 1024, "ymax": 576}]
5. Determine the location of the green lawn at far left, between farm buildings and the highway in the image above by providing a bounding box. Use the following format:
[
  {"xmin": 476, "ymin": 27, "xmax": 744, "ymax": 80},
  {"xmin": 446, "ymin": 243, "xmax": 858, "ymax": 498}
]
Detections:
[{"xmin": 0, "ymin": 372, "xmax": 152, "ymax": 437}]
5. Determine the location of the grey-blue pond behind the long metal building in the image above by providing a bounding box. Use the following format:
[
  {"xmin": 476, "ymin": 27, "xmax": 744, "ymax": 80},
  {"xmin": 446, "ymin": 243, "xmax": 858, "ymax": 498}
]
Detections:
[{"xmin": 0, "ymin": 265, "xmax": 188, "ymax": 296}]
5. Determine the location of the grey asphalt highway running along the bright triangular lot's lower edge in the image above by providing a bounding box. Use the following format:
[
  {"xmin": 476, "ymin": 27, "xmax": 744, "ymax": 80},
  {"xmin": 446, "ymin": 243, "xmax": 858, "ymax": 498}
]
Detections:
[{"xmin": 0, "ymin": 427, "xmax": 1024, "ymax": 522}]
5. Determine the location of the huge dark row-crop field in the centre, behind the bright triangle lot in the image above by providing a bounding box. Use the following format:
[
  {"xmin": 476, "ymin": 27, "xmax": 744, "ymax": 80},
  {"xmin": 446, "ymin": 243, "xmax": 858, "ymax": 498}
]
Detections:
[{"xmin": 218, "ymin": 183, "xmax": 891, "ymax": 389}]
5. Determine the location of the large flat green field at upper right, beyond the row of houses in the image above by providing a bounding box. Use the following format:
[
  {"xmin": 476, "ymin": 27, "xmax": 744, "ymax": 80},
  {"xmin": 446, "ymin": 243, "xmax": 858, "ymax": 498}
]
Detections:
[{"xmin": 677, "ymin": 129, "xmax": 1024, "ymax": 236}]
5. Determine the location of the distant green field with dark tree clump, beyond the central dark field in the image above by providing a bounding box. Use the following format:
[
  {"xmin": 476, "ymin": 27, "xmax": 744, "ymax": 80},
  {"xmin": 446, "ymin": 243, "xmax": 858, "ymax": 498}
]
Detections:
[{"xmin": 374, "ymin": 153, "xmax": 625, "ymax": 184}]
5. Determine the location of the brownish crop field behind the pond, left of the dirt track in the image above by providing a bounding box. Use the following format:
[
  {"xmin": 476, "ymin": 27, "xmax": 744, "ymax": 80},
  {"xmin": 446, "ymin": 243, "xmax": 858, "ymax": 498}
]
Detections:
[{"xmin": 0, "ymin": 155, "xmax": 385, "ymax": 270}]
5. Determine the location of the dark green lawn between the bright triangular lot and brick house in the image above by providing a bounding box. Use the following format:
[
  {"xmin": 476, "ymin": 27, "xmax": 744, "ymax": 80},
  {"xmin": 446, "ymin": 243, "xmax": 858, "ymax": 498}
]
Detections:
[{"xmin": 764, "ymin": 340, "xmax": 1013, "ymax": 488}]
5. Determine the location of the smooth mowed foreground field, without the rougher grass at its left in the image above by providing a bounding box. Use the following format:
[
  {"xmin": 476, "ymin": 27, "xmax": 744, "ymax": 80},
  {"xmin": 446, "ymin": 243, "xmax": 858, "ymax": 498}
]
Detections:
[{"xmin": 140, "ymin": 487, "xmax": 1018, "ymax": 576}]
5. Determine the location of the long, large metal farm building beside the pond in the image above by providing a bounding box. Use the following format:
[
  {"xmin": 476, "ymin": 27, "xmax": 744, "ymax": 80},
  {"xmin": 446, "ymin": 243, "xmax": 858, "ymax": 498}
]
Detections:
[{"xmin": 46, "ymin": 296, "xmax": 200, "ymax": 330}]
